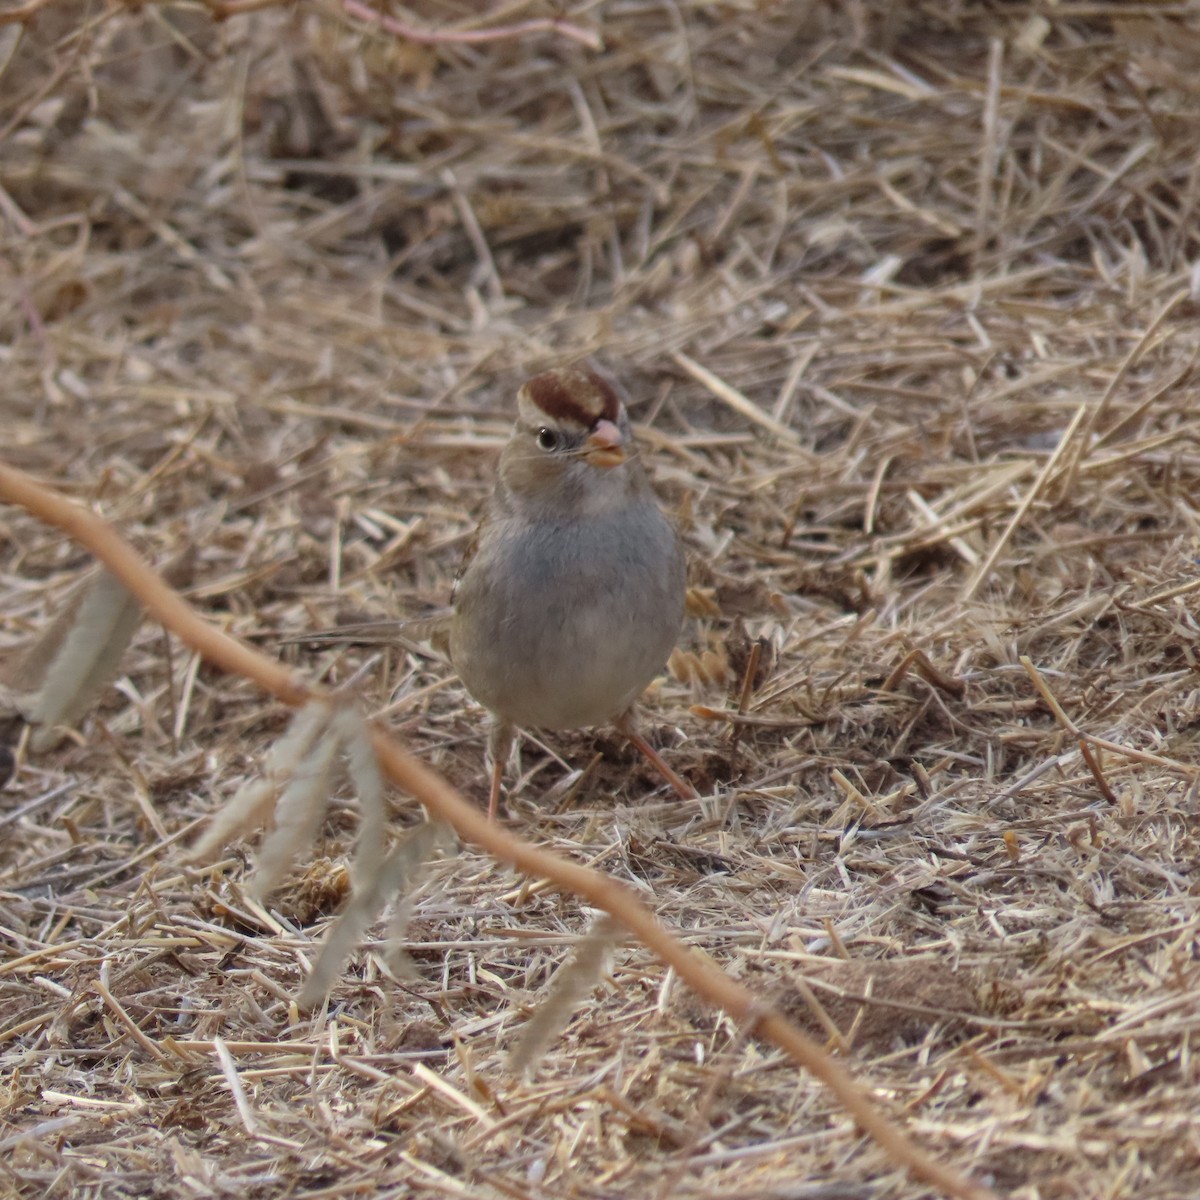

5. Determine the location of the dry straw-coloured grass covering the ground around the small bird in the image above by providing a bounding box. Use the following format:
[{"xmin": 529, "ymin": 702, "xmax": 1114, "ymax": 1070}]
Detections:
[{"xmin": 7, "ymin": 0, "xmax": 1200, "ymax": 1200}]
